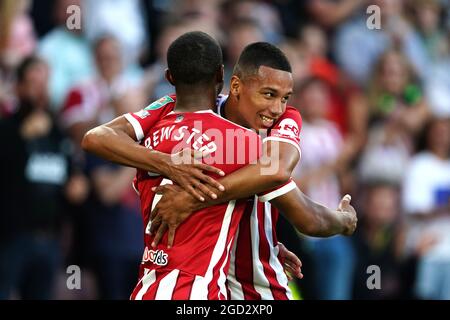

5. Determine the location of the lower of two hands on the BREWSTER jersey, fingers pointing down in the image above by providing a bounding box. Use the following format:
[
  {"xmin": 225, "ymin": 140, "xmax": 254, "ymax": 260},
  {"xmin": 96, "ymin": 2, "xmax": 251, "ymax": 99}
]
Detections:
[{"xmin": 150, "ymin": 184, "xmax": 194, "ymax": 248}]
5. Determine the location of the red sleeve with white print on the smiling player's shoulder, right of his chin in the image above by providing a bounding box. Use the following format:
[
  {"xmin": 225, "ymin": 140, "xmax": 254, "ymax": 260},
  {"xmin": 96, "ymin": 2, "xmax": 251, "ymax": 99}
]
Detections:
[{"xmin": 263, "ymin": 107, "xmax": 302, "ymax": 154}]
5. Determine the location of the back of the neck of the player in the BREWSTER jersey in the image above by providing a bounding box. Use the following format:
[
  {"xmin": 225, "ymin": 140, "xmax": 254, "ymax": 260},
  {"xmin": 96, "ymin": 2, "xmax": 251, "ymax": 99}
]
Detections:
[{"xmin": 175, "ymin": 86, "xmax": 217, "ymax": 112}]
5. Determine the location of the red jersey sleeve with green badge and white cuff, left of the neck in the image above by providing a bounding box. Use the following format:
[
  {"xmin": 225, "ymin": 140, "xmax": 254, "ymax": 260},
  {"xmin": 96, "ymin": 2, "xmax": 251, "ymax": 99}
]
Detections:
[{"xmin": 124, "ymin": 95, "xmax": 176, "ymax": 141}]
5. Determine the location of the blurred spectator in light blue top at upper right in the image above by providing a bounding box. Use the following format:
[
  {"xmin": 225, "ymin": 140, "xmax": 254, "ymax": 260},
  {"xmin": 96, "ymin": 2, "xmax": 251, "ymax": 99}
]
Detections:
[{"xmin": 333, "ymin": 0, "xmax": 429, "ymax": 86}]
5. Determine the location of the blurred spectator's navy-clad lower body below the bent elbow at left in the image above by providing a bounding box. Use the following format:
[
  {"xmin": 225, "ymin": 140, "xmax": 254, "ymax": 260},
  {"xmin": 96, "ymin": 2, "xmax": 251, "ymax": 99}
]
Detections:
[{"xmin": 82, "ymin": 154, "xmax": 144, "ymax": 300}]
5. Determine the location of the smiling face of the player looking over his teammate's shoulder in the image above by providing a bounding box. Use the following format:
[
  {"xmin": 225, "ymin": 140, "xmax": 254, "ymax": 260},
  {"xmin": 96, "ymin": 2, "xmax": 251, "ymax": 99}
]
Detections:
[{"xmin": 230, "ymin": 66, "xmax": 294, "ymax": 130}]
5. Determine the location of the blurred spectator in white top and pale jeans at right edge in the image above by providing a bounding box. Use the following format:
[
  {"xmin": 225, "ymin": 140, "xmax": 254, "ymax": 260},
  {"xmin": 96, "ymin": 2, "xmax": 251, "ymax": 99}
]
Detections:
[{"xmin": 403, "ymin": 119, "xmax": 450, "ymax": 299}]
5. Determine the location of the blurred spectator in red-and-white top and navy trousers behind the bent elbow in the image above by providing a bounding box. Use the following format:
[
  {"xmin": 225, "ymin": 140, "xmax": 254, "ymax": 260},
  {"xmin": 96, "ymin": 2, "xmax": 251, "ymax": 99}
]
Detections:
[{"xmin": 61, "ymin": 35, "xmax": 145, "ymax": 299}]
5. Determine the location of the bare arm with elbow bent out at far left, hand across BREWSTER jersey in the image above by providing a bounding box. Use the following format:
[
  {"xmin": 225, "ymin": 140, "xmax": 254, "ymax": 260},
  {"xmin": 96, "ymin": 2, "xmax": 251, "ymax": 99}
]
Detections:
[{"xmin": 81, "ymin": 114, "xmax": 224, "ymax": 201}]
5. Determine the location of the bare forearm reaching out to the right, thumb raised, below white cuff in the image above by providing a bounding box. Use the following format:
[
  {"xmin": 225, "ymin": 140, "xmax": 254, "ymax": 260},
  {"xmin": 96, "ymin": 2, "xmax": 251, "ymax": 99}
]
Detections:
[{"xmin": 270, "ymin": 188, "xmax": 357, "ymax": 237}]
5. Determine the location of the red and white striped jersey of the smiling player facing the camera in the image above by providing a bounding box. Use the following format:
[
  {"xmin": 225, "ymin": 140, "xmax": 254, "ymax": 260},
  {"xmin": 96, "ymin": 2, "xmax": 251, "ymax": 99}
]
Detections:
[{"xmin": 217, "ymin": 96, "xmax": 302, "ymax": 300}]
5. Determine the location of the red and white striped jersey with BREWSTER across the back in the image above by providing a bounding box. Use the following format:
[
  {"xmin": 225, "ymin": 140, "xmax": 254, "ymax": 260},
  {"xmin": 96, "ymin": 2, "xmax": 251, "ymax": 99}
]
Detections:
[{"xmin": 127, "ymin": 97, "xmax": 261, "ymax": 299}]
